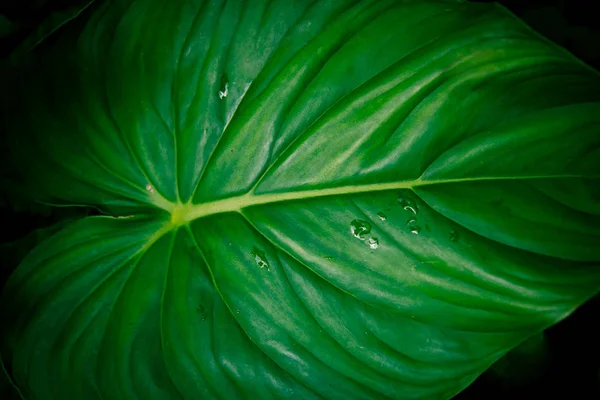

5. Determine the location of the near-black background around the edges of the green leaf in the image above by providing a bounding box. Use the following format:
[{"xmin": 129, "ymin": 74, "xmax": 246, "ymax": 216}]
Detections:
[{"xmin": 0, "ymin": 0, "xmax": 600, "ymax": 400}]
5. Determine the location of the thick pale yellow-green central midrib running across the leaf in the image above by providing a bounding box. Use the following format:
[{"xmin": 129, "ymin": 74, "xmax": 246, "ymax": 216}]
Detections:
[{"xmin": 170, "ymin": 175, "xmax": 594, "ymax": 226}]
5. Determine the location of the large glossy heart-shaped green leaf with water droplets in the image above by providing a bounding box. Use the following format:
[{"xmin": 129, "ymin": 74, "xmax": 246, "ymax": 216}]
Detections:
[{"xmin": 2, "ymin": 0, "xmax": 600, "ymax": 400}]
